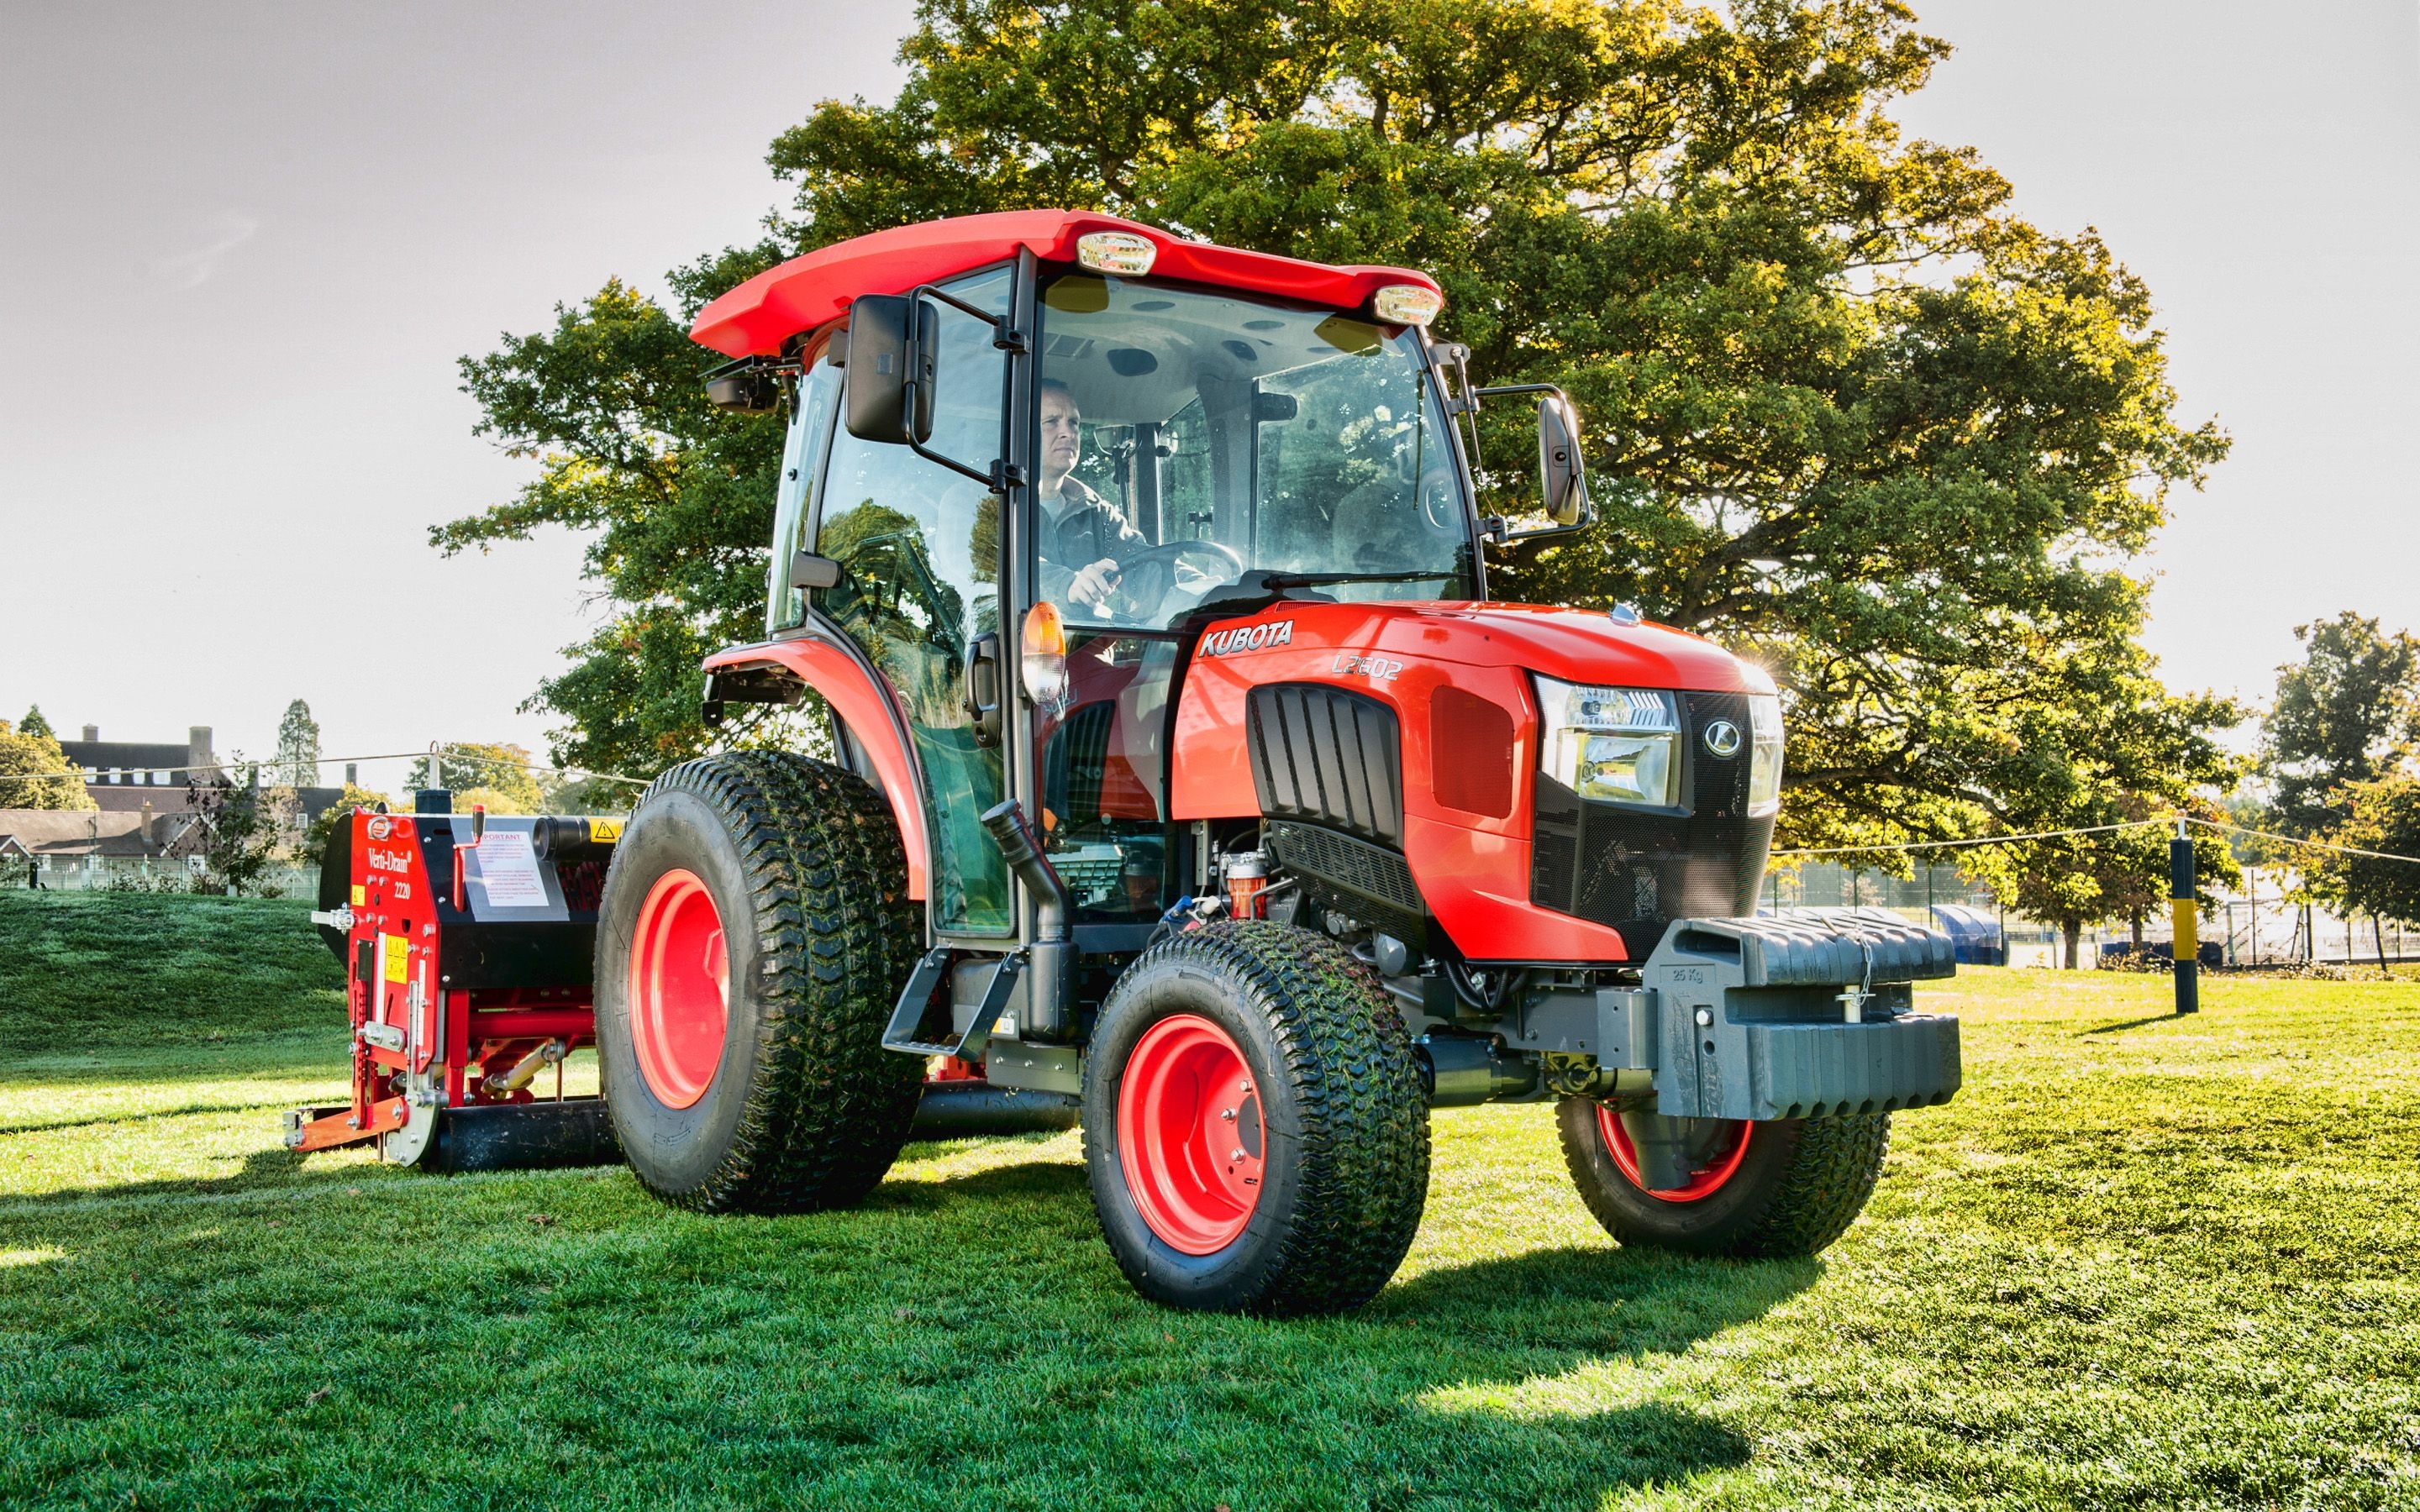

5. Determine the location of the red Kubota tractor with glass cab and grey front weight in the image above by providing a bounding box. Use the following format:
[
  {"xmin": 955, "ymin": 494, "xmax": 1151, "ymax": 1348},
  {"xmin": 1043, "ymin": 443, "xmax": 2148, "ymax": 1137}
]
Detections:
[{"xmin": 416, "ymin": 211, "xmax": 1958, "ymax": 1314}]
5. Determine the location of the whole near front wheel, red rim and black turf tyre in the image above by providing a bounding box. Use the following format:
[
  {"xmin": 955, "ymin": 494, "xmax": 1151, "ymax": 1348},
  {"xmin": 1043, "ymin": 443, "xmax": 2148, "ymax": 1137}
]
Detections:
[{"xmin": 1084, "ymin": 921, "xmax": 1428, "ymax": 1314}]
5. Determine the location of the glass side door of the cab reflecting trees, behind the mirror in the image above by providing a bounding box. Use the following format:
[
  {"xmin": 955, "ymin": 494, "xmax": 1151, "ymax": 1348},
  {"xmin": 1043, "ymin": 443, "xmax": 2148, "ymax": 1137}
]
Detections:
[{"xmin": 816, "ymin": 269, "xmax": 1017, "ymax": 937}]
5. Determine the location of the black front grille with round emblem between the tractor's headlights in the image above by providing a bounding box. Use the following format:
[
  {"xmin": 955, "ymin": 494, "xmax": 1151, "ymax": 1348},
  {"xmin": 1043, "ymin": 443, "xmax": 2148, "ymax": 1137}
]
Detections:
[{"xmin": 1529, "ymin": 692, "xmax": 1774, "ymax": 956}]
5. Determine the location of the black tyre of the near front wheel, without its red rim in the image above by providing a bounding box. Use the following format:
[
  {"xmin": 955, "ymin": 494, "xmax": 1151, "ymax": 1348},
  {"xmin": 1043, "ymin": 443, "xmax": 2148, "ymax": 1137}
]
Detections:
[{"xmin": 1084, "ymin": 921, "xmax": 1428, "ymax": 1316}]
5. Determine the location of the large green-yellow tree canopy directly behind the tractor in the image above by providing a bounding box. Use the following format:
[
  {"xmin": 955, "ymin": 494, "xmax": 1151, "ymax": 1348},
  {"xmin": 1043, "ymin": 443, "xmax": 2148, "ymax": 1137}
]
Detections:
[{"xmin": 450, "ymin": 0, "xmax": 2236, "ymax": 844}]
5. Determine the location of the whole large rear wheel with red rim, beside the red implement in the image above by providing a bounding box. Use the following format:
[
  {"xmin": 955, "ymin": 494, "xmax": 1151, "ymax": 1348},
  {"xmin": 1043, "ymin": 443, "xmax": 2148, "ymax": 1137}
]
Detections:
[{"xmin": 595, "ymin": 753, "xmax": 924, "ymax": 1212}]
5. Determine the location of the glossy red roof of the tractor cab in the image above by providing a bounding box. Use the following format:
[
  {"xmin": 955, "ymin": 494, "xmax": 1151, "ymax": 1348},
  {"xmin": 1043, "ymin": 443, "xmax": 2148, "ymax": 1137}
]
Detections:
[{"xmin": 690, "ymin": 211, "xmax": 1438, "ymax": 358}]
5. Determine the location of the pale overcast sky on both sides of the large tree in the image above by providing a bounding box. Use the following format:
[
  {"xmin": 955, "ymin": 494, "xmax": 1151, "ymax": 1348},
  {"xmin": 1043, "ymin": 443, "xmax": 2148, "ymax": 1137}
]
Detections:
[{"xmin": 0, "ymin": 0, "xmax": 2420, "ymax": 784}]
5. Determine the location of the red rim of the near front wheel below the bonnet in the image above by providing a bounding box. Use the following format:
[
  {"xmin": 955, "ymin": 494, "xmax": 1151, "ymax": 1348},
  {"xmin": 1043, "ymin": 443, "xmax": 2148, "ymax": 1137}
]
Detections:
[{"xmin": 1118, "ymin": 1014, "xmax": 1268, "ymax": 1256}]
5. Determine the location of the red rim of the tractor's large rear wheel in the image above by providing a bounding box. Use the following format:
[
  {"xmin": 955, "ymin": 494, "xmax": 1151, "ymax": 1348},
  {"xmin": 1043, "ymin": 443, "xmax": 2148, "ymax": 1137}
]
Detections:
[{"xmin": 629, "ymin": 869, "xmax": 731, "ymax": 1108}]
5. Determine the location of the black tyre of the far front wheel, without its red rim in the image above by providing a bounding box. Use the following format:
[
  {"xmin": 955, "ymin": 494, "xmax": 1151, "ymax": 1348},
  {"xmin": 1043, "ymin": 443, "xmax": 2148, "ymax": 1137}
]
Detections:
[{"xmin": 1556, "ymin": 1099, "xmax": 1890, "ymax": 1258}]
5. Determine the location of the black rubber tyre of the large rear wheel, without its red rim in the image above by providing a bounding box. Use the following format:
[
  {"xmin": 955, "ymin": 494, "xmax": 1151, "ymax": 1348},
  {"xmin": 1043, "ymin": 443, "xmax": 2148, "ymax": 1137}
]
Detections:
[{"xmin": 597, "ymin": 750, "xmax": 924, "ymax": 1212}]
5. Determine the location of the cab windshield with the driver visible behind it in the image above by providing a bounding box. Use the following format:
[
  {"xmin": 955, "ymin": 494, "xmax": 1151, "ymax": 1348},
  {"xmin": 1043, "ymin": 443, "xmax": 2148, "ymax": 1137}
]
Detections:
[{"xmin": 1034, "ymin": 273, "xmax": 1474, "ymax": 629}]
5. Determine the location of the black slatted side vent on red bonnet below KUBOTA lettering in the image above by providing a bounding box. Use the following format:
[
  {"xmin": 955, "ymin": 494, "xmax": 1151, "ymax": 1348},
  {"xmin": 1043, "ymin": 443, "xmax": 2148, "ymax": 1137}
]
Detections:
[{"xmin": 1244, "ymin": 682, "xmax": 1403, "ymax": 849}]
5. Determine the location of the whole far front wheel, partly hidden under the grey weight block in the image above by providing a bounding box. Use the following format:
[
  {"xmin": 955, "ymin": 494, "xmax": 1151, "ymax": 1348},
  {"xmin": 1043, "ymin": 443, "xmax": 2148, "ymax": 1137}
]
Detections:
[{"xmin": 1556, "ymin": 1099, "xmax": 1890, "ymax": 1258}]
